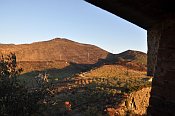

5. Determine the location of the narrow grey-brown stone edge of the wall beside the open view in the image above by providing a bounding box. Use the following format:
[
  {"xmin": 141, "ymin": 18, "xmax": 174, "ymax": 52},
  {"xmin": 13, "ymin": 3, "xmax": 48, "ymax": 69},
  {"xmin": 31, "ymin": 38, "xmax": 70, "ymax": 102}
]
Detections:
[{"xmin": 147, "ymin": 25, "xmax": 161, "ymax": 76}]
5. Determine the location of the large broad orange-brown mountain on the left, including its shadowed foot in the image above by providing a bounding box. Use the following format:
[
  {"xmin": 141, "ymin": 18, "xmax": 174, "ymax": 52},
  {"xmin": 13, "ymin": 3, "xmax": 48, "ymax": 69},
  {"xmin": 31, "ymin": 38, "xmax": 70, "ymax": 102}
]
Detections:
[{"xmin": 0, "ymin": 38, "xmax": 111, "ymax": 74}]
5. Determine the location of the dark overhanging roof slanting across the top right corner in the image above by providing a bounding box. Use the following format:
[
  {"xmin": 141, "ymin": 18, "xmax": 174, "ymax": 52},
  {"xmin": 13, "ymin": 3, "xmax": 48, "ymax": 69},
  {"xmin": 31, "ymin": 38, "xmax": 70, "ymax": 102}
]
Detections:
[{"xmin": 85, "ymin": 0, "xmax": 175, "ymax": 30}]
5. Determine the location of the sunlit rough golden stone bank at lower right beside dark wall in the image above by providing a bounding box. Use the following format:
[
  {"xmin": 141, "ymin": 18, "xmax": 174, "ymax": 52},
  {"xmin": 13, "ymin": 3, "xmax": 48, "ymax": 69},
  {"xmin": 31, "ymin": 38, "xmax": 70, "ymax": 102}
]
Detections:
[{"xmin": 107, "ymin": 87, "xmax": 151, "ymax": 116}]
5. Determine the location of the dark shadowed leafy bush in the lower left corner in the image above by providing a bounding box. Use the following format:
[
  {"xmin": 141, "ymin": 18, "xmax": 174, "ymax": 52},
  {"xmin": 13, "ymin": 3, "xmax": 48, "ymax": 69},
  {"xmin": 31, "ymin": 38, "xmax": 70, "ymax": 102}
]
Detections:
[{"xmin": 0, "ymin": 53, "xmax": 50, "ymax": 116}]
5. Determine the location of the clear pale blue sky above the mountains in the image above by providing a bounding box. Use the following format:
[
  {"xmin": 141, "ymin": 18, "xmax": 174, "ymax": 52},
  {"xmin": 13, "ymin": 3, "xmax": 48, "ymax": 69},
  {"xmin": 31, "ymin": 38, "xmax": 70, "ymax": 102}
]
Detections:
[{"xmin": 0, "ymin": 0, "xmax": 147, "ymax": 53}]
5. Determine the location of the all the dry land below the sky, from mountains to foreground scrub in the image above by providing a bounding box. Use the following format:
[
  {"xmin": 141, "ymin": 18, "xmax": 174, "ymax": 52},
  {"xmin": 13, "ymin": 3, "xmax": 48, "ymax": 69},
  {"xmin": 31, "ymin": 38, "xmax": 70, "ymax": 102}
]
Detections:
[{"xmin": 0, "ymin": 39, "xmax": 151, "ymax": 116}]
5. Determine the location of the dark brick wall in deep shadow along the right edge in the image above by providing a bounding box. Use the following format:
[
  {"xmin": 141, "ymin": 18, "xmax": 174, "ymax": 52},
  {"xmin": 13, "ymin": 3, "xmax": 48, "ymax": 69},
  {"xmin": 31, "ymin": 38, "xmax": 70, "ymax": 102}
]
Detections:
[{"xmin": 148, "ymin": 19, "xmax": 175, "ymax": 116}]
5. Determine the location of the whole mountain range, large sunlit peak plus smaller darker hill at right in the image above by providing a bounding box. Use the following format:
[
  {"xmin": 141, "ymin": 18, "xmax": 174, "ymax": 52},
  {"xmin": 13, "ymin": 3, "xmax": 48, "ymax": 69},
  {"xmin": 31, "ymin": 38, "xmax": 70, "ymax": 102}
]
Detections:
[{"xmin": 0, "ymin": 38, "xmax": 147, "ymax": 77}]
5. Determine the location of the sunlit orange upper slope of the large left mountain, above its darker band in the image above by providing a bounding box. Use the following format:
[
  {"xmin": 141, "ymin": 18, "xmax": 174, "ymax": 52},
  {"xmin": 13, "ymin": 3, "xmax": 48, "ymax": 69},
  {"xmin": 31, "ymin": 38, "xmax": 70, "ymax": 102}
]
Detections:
[{"xmin": 0, "ymin": 38, "xmax": 109, "ymax": 64}]
